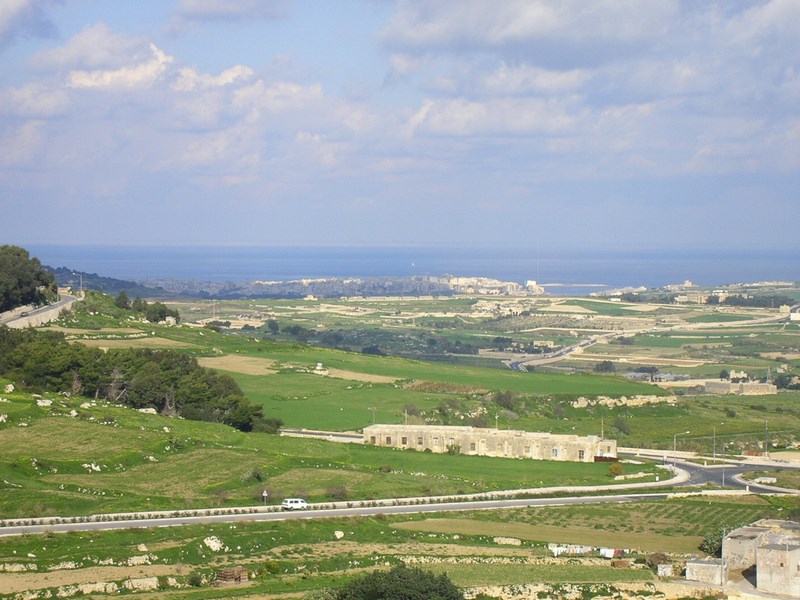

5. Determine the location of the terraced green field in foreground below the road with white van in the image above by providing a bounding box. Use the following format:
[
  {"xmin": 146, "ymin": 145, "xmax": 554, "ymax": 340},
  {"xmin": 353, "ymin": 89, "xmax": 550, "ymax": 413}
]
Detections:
[{"xmin": 0, "ymin": 496, "xmax": 796, "ymax": 599}]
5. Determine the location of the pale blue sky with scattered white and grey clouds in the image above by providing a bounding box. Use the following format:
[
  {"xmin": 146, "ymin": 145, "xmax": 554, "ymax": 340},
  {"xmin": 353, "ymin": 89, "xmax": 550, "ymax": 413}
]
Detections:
[{"xmin": 0, "ymin": 0, "xmax": 800, "ymax": 252}]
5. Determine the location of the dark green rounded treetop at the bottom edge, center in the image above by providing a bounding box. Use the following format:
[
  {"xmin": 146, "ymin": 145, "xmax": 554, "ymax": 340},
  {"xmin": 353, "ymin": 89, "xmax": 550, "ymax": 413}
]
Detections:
[{"xmin": 335, "ymin": 565, "xmax": 464, "ymax": 600}]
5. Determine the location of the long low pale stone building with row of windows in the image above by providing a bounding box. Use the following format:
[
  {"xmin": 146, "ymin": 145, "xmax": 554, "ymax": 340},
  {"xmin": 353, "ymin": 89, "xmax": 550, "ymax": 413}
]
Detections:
[{"xmin": 364, "ymin": 425, "xmax": 617, "ymax": 462}]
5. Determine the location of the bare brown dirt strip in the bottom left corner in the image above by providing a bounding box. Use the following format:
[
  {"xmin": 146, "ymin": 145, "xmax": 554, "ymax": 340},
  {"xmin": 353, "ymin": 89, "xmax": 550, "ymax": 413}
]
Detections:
[{"xmin": 0, "ymin": 565, "xmax": 180, "ymax": 594}]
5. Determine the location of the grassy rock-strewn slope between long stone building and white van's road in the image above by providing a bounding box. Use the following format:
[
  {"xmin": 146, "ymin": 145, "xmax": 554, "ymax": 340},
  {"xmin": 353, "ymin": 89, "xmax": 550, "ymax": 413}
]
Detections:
[{"xmin": 0, "ymin": 384, "xmax": 657, "ymax": 518}]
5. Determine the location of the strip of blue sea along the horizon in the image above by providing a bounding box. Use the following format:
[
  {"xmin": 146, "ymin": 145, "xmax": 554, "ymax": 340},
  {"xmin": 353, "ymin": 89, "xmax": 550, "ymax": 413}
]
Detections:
[{"xmin": 26, "ymin": 245, "xmax": 800, "ymax": 295}]
